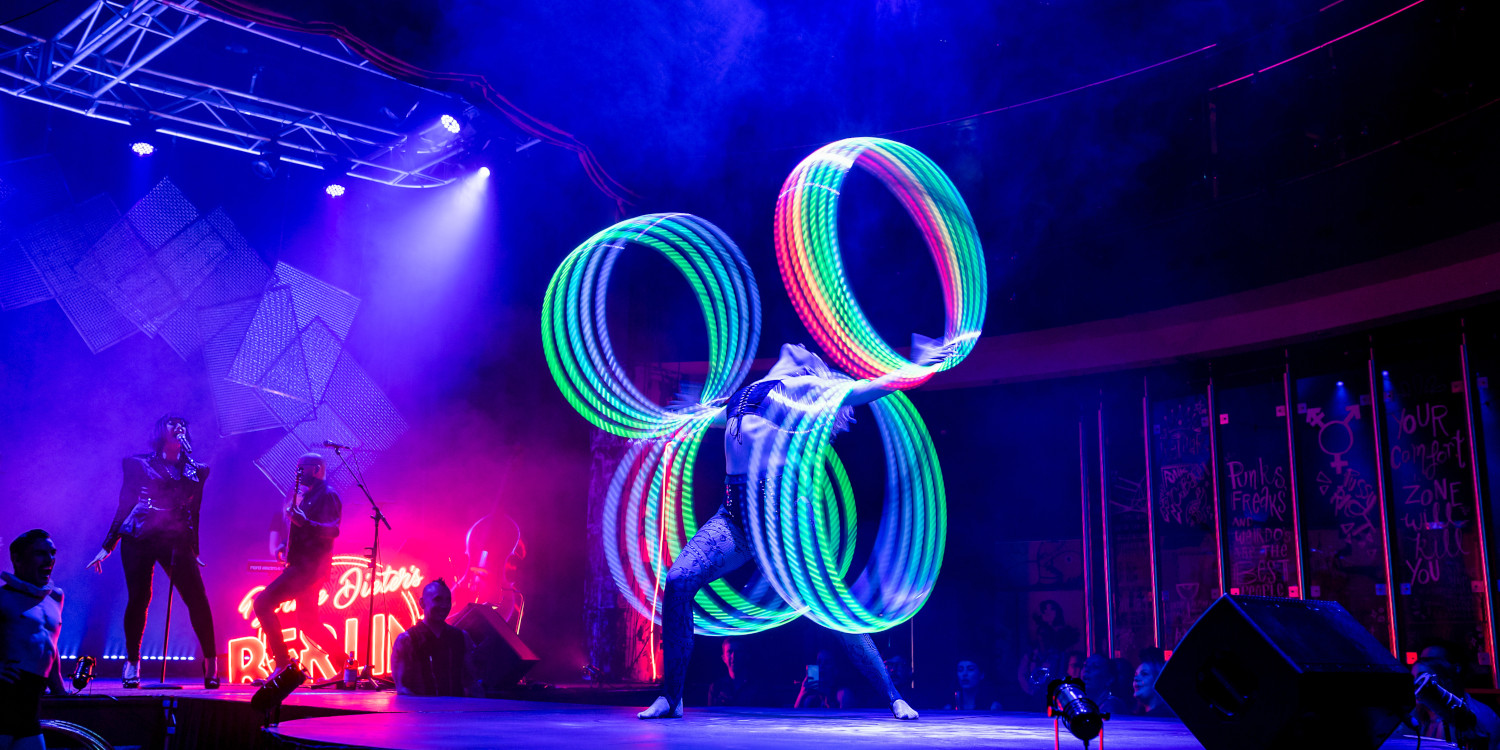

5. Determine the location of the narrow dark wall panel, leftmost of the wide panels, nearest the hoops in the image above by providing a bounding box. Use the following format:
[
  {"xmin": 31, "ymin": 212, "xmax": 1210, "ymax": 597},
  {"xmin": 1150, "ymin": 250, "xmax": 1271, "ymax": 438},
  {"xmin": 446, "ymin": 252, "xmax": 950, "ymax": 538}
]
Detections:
[{"xmin": 1100, "ymin": 398, "xmax": 1157, "ymax": 659}]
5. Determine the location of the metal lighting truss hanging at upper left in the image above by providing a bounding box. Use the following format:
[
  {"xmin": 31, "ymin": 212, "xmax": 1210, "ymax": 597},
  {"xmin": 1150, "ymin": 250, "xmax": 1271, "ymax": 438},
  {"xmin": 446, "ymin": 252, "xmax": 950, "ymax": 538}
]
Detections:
[{"xmin": 0, "ymin": 0, "xmax": 477, "ymax": 188}]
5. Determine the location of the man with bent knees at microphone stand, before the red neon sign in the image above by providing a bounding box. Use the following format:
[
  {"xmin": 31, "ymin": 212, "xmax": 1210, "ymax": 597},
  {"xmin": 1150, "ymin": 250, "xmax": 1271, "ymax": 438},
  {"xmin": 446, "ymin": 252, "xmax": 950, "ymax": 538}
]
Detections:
[{"xmin": 255, "ymin": 453, "xmax": 344, "ymax": 668}]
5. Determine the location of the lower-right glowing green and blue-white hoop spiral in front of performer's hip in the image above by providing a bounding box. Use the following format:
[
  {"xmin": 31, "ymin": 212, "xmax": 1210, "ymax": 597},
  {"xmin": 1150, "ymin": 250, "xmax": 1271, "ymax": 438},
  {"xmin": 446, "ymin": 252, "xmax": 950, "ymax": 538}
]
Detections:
[{"xmin": 749, "ymin": 386, "xmax": 948, "ymax": 633}]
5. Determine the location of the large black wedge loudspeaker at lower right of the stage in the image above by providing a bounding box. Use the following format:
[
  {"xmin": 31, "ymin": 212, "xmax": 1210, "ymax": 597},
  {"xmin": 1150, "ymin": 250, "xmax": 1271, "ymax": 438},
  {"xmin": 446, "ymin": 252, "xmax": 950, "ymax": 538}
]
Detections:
[{"xmin": 1157, "ymin": 596, "xmax": 1413, "ymax": 750}]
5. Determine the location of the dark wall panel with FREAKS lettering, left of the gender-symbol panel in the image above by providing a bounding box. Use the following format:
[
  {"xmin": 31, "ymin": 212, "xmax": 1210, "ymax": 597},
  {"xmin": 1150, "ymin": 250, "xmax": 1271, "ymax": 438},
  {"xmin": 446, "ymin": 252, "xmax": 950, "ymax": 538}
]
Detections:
[{"xmin": 1214, "ymin": 380, "xmax": 1301, "ymax": 597}]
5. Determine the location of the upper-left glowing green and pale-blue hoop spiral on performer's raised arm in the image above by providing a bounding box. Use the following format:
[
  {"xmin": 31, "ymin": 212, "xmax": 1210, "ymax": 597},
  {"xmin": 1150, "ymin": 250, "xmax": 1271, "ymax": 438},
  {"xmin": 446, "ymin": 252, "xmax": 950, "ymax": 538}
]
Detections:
[{"xmin": 542, "ymin": 213, "xmax": 761, "ymax": 438}]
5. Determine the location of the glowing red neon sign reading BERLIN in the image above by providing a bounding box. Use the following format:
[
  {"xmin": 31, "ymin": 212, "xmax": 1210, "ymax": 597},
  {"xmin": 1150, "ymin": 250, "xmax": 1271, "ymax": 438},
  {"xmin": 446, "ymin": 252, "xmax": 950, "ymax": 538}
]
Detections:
[{"xmin": 228, "ymin": 555, "xmax": 426, "ymax": 683}]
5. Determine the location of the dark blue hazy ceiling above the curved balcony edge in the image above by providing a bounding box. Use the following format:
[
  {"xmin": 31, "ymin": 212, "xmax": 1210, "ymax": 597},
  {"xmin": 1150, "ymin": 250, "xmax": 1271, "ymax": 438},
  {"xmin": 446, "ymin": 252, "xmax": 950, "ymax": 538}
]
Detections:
[{"xmin": 2, "ymin": 0, "xmax": 1500, "ymax": 351}]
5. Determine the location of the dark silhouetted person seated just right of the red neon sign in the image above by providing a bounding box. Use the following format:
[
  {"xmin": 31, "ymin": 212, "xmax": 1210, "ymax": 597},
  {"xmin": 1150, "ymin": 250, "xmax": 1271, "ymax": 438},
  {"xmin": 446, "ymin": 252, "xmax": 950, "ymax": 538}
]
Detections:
[{"xmin": 390, "ymin": 578, "xmax": 480, "ymax": 698}]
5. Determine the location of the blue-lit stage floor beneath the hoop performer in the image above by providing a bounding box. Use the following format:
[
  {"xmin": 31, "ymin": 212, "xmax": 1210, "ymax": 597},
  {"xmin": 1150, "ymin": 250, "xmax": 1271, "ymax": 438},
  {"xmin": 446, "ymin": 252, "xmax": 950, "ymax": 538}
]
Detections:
[{"xmin": 55, "ymin": 683, "xmax": 1452, "ymax": 750}]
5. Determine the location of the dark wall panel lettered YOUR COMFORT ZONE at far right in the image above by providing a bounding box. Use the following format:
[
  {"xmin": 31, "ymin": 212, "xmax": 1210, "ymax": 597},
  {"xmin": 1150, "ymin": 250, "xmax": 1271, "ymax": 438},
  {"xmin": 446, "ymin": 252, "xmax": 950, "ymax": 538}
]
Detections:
[{"xmin": 1380, "ymin": 358, "xmax": 1491, "ymax": 666}]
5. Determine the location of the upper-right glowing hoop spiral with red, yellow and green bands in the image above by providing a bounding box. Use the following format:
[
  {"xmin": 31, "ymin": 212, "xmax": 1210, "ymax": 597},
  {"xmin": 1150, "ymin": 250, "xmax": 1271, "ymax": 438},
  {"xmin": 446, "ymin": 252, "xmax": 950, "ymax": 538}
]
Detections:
[{"xmin": 776, "ymin": 138, "xmax": 989, "ymax": 389}]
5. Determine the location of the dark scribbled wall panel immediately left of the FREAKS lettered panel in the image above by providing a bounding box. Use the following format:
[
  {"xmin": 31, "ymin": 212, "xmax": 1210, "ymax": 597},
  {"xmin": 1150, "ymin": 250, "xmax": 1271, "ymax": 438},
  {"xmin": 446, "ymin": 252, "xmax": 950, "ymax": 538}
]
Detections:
[{"xmin": 1151, "ymin": 395, "xmax": 1220, "ymax": 651}]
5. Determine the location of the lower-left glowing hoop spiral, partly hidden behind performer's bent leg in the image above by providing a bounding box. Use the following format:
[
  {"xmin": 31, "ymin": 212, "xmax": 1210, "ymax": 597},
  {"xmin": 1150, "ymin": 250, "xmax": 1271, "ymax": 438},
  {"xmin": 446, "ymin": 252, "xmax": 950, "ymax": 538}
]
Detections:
[{"xmin": 602, "ymin": 414, "xmax": 857, "ymax": 636}]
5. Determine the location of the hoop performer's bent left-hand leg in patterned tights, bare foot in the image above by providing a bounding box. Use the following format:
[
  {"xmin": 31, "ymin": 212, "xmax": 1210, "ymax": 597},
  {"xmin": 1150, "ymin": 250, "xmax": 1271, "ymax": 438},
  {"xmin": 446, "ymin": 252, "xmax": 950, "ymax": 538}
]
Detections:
[{"xmin": 638, "ymin": 510, "xmax": 750, "ymax": 719}]
